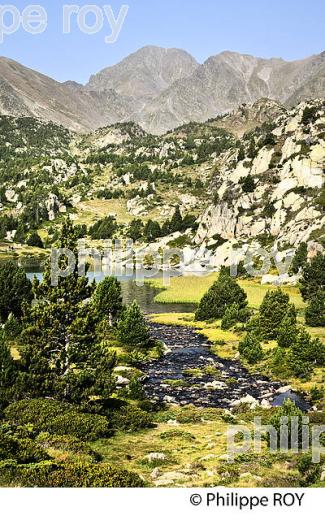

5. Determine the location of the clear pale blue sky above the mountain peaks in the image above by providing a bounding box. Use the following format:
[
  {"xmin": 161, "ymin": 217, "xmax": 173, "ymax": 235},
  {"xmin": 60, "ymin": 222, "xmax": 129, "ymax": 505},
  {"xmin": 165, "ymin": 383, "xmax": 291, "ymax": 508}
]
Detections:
[{"xmin": 0, "ymin": 0, "xmax": 325, "ymax": 83}]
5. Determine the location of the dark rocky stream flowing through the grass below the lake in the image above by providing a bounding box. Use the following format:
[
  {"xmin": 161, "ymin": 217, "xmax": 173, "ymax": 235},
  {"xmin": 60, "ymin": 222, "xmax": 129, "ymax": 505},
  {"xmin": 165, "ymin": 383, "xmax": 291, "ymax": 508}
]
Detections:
[{"xmin": 141, "ymin": 323, "xmax": 308, "ymax": 409}]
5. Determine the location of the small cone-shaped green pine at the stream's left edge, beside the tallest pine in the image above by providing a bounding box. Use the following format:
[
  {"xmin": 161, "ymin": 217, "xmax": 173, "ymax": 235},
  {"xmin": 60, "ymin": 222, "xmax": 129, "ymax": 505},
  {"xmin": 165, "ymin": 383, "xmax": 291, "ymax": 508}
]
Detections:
[{"xmin": 117, "ymin": 301, "xmax": 150, "ymax": 348}]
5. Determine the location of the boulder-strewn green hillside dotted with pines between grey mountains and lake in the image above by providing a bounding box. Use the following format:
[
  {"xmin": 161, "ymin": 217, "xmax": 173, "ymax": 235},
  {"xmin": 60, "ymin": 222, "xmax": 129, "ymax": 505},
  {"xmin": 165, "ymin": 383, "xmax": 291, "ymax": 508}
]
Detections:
[{"xmin": 0, "ymin": 99, "xmax": 325, "ymax": 269}]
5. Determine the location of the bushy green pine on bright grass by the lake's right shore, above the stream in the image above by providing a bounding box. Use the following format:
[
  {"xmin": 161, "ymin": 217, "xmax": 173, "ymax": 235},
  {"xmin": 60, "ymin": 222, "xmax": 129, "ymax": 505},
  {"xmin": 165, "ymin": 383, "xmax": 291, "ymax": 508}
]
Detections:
[{"xmin": 195, "ymin": 269, "xmax": 247, "ymax": 321}]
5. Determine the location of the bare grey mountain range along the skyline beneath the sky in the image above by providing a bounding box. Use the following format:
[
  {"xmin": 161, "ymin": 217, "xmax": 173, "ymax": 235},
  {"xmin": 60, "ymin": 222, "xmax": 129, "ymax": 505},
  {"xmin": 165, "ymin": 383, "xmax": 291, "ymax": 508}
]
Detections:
[{"xmin": 0, "ymin": 46, "xmax": 325, "ymax": 134}]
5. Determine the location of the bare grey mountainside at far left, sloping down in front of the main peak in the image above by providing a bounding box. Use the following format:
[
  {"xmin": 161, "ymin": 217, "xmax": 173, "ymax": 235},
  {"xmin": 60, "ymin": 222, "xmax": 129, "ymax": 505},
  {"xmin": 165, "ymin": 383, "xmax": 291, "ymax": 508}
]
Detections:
[{"xmin": 0, "ymin": 58, "xmax": 133, "ymax": 132}]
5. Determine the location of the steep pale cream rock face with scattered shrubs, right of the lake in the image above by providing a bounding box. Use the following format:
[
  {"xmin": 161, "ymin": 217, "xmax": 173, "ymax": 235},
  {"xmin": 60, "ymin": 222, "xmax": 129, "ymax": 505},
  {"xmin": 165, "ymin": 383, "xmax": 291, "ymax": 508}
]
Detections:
[{"xmin": 191, "ymin": 100, "xmax": 325, "ymax": 274}]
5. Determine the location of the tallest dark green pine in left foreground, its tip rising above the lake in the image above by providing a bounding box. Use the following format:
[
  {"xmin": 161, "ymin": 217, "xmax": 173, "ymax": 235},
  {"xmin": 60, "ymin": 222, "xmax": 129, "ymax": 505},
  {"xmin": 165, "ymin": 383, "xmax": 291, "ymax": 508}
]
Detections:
[{"xmin": 21, "ymin": 221, "xmax": 96, "ymax": 395}]
